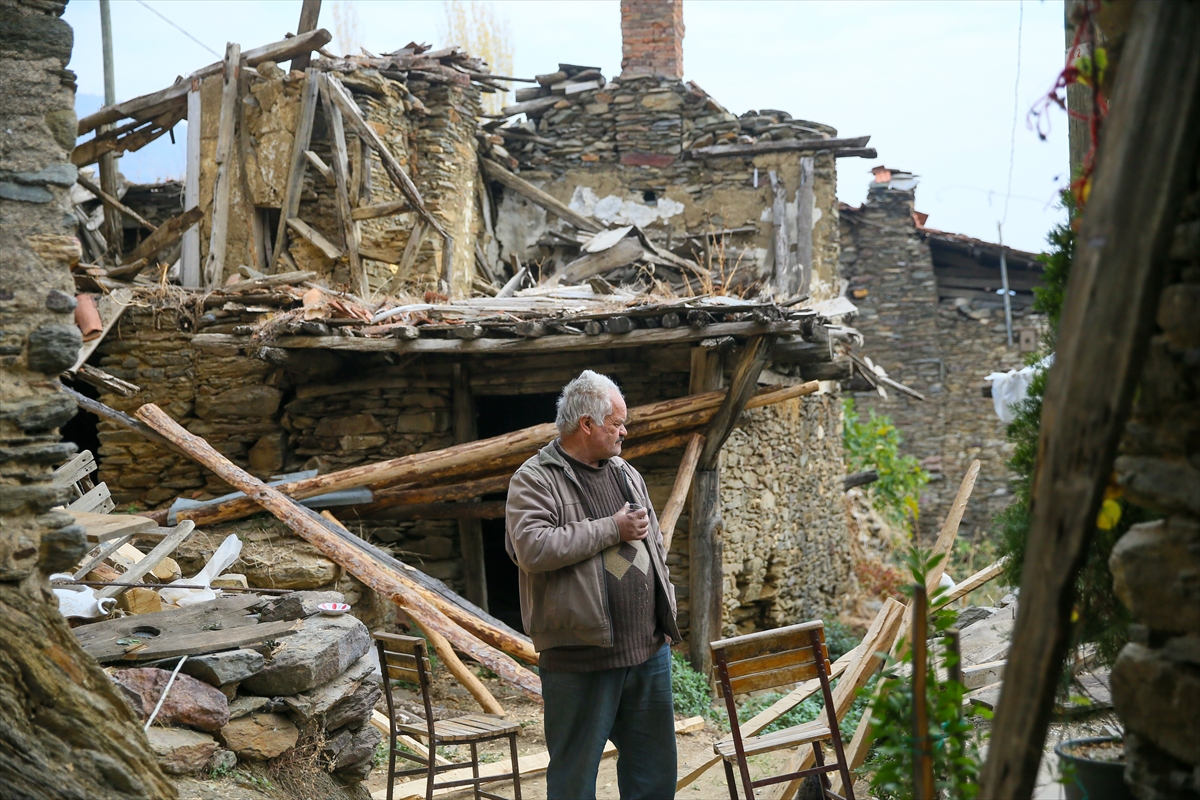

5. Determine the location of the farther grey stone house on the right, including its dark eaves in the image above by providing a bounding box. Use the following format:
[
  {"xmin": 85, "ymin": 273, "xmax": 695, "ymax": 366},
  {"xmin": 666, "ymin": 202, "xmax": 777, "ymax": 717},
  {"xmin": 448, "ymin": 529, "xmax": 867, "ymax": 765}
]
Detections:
[{"xmin": 840, "ymin": 167, "xmax": 1045, "ymax": 544}]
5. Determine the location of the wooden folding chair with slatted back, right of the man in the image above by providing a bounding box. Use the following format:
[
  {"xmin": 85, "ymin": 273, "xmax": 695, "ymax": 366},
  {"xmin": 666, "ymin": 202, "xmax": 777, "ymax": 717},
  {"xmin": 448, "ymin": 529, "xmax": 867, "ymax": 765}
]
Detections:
[{"xmin": 709, "ymin": 620, "xmax": 854, "ymax": 800}]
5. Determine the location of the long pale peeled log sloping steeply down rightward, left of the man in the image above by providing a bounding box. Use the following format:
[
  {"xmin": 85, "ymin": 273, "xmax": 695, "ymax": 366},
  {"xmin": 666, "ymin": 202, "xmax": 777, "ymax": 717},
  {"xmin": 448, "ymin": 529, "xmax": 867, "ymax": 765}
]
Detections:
[{"xmin": 137, "ymin": 403, "xmax": 541, "ymax": 703}]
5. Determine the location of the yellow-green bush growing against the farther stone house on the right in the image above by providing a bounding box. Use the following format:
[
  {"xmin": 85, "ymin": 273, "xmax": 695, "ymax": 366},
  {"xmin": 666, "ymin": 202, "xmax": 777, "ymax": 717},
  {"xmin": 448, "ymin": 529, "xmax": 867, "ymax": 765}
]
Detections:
[{"xmin": 842, "ymin": 397, "xmax": 929, "ymax": 527}]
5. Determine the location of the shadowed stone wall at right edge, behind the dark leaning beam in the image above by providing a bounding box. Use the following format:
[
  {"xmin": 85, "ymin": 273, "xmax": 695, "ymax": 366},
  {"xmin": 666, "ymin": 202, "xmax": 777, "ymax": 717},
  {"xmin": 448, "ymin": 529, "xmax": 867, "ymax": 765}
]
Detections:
[{"xmin": 1109, "ymin": 167, "xmax": 1200, "ymax": 800}]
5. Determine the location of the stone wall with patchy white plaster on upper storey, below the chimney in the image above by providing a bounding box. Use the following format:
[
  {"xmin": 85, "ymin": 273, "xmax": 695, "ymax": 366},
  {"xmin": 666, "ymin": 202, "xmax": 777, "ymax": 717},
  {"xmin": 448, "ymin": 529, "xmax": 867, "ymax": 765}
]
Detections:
[{"xmin": 497, "ymin": 78, "xmax": 839, "ymax": 300}]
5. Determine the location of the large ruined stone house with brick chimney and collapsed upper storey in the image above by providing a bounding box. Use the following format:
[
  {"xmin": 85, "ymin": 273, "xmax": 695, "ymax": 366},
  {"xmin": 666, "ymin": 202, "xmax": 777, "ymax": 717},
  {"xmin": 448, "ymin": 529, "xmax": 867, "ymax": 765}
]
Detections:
[{"xmin": 65, "ymin": 1, "xmax": 892, "ymax": 681}]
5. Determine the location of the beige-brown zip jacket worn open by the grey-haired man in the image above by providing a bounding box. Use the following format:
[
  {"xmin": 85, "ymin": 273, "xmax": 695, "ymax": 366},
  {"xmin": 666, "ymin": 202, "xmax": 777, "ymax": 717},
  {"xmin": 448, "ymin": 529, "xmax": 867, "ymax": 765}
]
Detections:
[{"xmin": 504, "ymin": 443, "xmax": 683, "ymax": 651}]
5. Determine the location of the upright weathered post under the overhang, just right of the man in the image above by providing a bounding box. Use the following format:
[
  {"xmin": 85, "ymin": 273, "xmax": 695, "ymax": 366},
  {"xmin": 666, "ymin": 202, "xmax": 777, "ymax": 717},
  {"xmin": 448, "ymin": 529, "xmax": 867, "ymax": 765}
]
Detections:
[{"xmin": 688, "ymin": 347, "xmax": 728, "ymax": 678}]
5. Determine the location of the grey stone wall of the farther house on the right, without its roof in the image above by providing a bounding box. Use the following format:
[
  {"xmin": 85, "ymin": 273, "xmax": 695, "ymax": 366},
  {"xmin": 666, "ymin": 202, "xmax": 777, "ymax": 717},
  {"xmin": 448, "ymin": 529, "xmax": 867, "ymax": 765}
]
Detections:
[{"xmin": 841, "ymin": 185, "xmax": 1042, "ymax": 536}]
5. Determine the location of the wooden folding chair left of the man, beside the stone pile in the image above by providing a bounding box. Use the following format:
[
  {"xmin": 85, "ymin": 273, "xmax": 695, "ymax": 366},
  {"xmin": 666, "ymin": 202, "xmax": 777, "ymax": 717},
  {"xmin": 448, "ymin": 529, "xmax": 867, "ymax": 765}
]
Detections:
[{"xmin": 372, "ymin": 631, "xmax": 521, "ymax": 800}]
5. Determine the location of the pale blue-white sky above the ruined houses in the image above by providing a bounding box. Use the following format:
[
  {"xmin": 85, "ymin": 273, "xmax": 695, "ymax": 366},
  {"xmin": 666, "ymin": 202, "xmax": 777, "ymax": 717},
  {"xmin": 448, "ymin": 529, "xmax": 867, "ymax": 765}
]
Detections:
[{"xmin": 65, "ymin": 0, "xmax": 1068, "ymax": 251}]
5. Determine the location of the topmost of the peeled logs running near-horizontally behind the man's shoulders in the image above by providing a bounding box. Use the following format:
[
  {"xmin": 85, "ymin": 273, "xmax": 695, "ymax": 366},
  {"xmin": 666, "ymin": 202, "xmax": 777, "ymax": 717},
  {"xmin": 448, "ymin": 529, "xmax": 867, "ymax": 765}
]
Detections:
[{"xmin": 179, "ymin": 381, "xmax": 820, "ymax": 525}]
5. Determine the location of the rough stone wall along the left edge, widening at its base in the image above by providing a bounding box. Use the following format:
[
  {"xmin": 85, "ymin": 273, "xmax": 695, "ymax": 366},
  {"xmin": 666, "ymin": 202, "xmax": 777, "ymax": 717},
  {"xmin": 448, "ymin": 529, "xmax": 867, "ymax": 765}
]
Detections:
[{"xmin": 0, "ymin": 0, "xmax": 175, "ymax": 800}]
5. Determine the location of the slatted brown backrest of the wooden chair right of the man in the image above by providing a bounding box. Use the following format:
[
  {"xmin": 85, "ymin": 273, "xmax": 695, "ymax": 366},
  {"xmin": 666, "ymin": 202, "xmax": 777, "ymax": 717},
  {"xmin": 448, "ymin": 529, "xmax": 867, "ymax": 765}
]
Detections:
[{"xmin": 709, "ymin": 620, "xmax": 829, "ymax": 697}]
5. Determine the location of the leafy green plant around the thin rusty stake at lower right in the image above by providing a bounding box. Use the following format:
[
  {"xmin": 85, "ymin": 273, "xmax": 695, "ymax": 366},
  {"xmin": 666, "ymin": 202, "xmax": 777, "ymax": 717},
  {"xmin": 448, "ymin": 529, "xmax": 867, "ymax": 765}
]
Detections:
[{"xmin": 863, "ymin": 548, "xmax": 990, "ymax": 800}]
